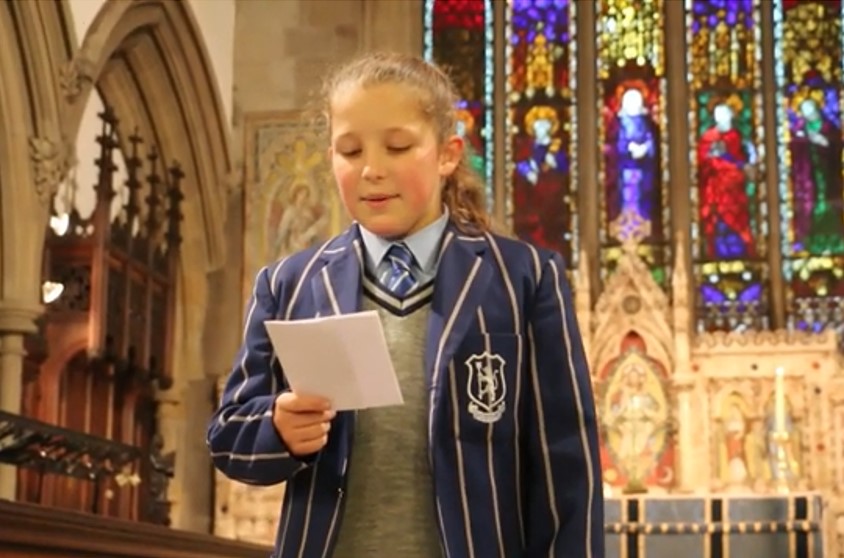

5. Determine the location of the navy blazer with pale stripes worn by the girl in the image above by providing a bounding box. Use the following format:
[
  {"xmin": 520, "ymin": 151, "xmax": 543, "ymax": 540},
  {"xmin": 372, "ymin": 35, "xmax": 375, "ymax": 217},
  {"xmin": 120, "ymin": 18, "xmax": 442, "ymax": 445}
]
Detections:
[{"xmin": 207, "ymin": 225, "xmax": 604, "ymax": 558}]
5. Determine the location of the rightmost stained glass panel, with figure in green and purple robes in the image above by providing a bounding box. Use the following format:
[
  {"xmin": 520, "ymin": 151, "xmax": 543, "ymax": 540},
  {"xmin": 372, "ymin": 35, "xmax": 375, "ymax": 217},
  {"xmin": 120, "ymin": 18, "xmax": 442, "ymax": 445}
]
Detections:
[{"xmin": 774, "ymin": 0, "xmax": 844, "ymax": 340}]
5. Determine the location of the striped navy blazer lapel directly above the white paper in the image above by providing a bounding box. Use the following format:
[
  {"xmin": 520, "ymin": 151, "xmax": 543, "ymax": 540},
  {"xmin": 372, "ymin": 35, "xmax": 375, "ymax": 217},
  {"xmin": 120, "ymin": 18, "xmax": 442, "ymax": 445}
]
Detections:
[{"xmin": 311, "ymin": 225, "xmax": 363, "ymax": 316}]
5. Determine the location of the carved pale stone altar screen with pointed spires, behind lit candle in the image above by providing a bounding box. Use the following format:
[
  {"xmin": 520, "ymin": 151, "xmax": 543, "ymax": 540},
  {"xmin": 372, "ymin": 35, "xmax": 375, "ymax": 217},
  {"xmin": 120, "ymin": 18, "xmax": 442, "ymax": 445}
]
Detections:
[{"xmin": 575, "ymin": 214, "xmax": 844, "ymax": 556}]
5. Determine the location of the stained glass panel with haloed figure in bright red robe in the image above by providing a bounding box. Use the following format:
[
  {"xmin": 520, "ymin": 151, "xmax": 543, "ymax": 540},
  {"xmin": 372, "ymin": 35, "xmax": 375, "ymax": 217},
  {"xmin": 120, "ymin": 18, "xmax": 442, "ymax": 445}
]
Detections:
[{"xmin": 686, "ymin": 0, "xmax": 770, "ymax": 330}]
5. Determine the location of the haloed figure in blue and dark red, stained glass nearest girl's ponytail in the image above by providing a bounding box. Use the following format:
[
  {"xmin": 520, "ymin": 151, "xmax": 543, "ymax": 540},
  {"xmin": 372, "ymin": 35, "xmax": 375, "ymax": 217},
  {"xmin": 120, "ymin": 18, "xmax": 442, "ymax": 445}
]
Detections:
[{"xmin": 513, "ymin": 105, "xmax": 569, "ymax": 254}]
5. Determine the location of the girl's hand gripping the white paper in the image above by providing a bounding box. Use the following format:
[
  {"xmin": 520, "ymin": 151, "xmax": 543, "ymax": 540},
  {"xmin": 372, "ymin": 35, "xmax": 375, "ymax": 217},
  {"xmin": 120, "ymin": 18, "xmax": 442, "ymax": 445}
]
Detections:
[{"xmin": 273, "ymin": 391, "xmax": 336, "ymax": 457}]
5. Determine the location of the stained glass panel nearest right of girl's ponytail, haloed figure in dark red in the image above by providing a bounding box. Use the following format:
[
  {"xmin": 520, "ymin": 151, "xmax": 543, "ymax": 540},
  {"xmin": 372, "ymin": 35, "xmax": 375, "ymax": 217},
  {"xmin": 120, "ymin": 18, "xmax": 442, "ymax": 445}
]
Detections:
[{"xmin": 506, "ymin": 0, "xmax": 577, "ymax": 269}]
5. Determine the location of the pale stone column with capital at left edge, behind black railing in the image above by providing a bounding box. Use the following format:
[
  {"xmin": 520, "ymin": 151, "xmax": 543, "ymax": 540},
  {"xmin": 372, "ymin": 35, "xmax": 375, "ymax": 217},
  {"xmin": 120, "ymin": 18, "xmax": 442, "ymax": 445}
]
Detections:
[{"xmin": 0, "ymin": 301, "xmax": 42, "ymax": 500}]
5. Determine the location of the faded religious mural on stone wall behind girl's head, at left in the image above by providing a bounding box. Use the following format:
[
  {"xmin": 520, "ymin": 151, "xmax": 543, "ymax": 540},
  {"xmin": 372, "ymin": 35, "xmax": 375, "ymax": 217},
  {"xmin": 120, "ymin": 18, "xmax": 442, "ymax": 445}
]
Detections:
[{"xmin": 244, "ymin": 112, "xmax": 346, "ymax": 300}]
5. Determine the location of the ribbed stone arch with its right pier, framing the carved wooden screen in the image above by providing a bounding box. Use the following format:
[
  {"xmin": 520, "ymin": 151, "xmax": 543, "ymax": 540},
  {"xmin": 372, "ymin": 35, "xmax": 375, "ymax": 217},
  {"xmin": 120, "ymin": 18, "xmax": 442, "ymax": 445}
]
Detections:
[{"xmin": 62, "ymin": 0, "xmax": 234, "ymax": 528}]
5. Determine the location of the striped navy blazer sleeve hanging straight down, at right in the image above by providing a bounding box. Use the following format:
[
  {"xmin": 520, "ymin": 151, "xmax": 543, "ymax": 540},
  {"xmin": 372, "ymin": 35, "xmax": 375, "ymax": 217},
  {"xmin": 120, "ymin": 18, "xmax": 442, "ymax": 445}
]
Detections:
[{"xmin": 525, "ymin": 253, "xmax": 604, "ymax": 558}]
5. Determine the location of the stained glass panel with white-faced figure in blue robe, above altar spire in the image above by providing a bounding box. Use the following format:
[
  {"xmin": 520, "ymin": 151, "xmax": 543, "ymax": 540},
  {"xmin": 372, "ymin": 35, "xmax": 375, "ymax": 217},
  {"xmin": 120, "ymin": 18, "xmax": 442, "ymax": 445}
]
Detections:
[{"xmin": 596, "ymin": 0, "xmax": 669, "ymax": 284}]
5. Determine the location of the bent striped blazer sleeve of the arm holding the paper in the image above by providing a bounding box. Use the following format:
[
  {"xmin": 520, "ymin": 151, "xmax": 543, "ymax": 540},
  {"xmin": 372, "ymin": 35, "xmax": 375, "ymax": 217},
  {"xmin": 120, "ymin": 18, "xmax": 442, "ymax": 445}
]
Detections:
[{"xmin": 207, "ymin": 268, "xmax": 305, "ymax": 485}]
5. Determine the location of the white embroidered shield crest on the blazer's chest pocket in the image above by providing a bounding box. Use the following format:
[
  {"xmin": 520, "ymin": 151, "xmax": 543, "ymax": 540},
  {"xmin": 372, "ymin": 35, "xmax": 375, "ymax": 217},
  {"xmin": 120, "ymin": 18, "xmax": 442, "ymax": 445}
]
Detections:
[{"xmin": 466, "ymin": 351, "xmax": 507, "ymax": 423}]
